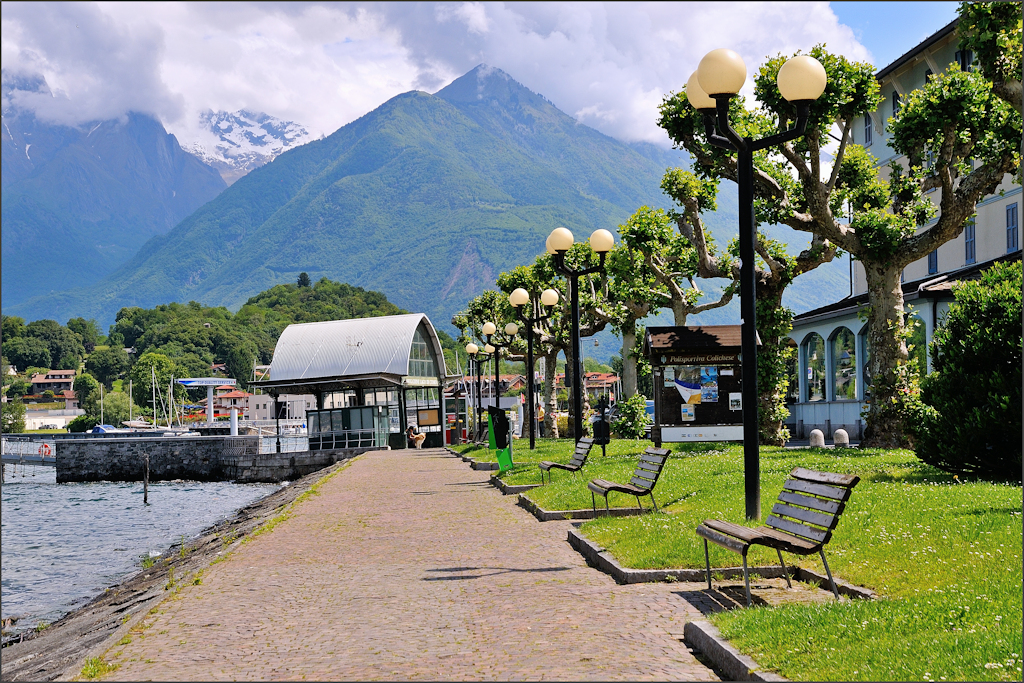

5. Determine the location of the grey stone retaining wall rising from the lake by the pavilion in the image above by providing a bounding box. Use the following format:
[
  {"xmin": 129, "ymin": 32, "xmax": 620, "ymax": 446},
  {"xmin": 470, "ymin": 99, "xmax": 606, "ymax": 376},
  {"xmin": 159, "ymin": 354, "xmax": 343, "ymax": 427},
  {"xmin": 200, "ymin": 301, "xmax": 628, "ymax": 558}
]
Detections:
[{"xmin": 54, "ymin": 436, "xmax": 379, "ymax": 483}]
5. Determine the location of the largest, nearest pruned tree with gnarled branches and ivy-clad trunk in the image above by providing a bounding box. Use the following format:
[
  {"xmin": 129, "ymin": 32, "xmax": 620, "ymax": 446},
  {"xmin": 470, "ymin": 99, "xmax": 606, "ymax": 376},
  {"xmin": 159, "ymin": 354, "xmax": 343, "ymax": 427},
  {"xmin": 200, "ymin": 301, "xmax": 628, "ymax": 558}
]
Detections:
[{"xmin": 662, "ymin": 17, "xmax": 1021, "ymax": 445}]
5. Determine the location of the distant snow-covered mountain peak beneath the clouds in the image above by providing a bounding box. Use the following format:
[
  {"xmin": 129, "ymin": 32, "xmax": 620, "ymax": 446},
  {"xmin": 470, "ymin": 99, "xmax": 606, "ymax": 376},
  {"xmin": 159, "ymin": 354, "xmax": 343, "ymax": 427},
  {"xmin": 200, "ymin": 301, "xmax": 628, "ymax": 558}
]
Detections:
[{"xmin": 185, "ymin": 110, "xmax": 312, "ymax": 185}]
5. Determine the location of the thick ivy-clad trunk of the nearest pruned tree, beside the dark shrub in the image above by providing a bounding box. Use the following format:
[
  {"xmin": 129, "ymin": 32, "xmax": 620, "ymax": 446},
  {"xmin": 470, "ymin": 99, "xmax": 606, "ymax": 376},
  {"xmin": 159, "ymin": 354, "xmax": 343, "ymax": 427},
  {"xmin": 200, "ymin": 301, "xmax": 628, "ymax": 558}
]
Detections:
[{"xmin": 862, "ymin": 261, "xmax": 910, "ymax": 447}]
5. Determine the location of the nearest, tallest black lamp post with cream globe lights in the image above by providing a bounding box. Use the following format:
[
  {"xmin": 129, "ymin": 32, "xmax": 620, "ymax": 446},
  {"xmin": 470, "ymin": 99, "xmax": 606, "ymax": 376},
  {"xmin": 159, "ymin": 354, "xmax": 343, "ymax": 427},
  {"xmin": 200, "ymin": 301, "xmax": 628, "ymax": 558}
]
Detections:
[{"xmin": 686, "ymin": 49, "xmax": 828, "ymax": 519}]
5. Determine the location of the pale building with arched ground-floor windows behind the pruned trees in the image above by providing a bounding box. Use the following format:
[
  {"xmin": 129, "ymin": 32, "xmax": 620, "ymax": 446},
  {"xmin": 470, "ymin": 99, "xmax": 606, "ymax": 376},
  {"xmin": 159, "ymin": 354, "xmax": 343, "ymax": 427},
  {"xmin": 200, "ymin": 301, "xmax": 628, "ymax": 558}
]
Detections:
[{"xmin": 787, "ymin": 20, "xmax": 1021, "ymax": 438}]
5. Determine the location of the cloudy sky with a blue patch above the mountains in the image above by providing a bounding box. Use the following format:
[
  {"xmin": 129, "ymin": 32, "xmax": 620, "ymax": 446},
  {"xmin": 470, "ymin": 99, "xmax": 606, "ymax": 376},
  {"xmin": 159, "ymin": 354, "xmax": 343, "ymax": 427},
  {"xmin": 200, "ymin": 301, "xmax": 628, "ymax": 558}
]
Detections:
[{"xmin": 0, "ymin": 2, "xmax": 956, "ymax": 145}]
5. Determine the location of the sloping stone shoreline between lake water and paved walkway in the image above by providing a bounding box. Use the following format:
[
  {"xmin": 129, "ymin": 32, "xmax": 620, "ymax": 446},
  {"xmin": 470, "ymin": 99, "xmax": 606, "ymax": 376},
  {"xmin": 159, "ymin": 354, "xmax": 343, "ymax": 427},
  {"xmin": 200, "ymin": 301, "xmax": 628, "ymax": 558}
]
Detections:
[{"xmin": 0, "ymin": 459, "xmax": 350, "ymax": 681}]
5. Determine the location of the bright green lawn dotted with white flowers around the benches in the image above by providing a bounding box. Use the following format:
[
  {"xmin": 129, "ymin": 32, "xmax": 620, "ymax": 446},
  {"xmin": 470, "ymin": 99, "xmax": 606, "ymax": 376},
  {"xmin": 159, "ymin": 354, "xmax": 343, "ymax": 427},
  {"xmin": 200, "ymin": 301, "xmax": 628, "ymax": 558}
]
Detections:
[{"xmin": 503, "ymin": 441, "xmax": 1024, "ymax": 681}]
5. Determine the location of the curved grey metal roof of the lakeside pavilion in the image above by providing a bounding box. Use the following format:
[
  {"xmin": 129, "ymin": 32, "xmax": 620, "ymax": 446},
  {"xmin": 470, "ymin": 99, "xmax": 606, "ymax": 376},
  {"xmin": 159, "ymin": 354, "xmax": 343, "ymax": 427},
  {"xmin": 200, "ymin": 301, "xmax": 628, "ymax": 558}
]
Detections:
[{"xmin": 269, "ymin": 313, "xmax": 445, "ymax": 383}]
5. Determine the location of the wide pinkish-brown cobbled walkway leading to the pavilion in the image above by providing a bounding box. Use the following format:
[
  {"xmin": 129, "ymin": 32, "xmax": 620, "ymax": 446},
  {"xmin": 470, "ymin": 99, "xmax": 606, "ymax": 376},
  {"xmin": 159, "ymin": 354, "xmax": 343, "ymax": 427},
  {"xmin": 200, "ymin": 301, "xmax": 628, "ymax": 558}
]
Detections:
[{"xmin": 106, "ymin": 450, "xmax": 717, "ymax": 681}]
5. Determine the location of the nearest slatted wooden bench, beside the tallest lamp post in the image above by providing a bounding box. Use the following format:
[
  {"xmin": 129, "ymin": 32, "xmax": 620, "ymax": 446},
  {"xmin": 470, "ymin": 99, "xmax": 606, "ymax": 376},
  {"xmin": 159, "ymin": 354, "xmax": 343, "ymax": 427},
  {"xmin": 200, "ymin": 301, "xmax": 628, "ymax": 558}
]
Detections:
[{"xmin": 697, "ymin": 467, "xmax": 860, "ymax": 606}]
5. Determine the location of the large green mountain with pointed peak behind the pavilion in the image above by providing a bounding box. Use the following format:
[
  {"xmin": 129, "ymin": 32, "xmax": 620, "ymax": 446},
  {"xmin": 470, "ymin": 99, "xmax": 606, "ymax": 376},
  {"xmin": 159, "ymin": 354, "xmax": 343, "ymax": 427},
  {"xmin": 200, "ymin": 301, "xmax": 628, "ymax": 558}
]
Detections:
[{"xmin": 11, "ymin": 67, "xmax": 696, "ymax": 326}]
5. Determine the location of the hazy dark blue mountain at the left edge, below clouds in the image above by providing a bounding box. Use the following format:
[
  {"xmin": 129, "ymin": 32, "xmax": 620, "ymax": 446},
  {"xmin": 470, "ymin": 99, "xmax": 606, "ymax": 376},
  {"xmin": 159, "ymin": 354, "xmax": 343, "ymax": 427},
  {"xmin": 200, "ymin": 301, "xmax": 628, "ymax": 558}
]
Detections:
[{"xmin": 0, "ymin": 74, "xmax": 226, "ymax": 311}]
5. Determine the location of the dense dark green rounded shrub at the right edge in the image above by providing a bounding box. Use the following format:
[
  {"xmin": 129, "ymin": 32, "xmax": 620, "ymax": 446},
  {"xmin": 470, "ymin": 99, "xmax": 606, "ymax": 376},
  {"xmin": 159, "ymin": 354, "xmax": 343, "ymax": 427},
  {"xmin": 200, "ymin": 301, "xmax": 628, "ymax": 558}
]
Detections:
[{"xmin": 916, "ymin": 261, "xmax": 1022, "ymax": 481}]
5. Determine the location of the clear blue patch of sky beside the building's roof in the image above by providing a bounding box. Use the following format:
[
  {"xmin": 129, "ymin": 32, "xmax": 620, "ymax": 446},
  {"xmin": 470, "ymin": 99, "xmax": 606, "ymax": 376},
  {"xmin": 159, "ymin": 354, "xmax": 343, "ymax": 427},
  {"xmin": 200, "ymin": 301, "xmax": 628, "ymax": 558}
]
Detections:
[{"xmin": 829, "ymin": 2, "xmax": 958, "ymax": 70}]
